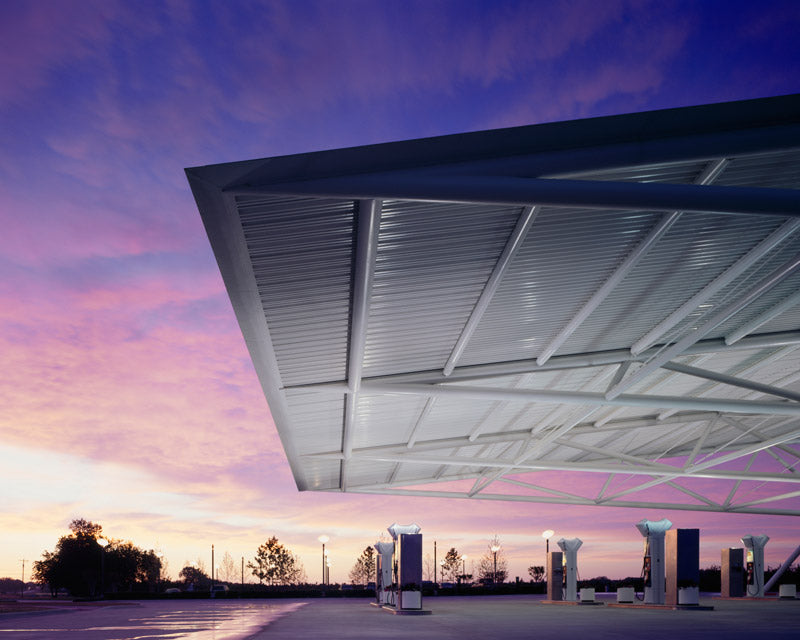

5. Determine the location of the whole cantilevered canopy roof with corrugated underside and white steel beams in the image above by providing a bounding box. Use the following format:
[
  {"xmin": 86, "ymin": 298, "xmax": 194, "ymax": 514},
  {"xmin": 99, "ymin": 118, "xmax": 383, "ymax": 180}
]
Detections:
[{"xmin": 187, "ymin": 95, "xmax": 800, "ymax": 515}]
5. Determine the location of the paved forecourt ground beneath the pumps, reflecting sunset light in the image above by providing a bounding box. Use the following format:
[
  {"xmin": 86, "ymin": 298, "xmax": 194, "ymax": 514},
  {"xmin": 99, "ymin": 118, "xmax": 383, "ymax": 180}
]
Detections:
[{"xmin": 0, "ymin": 594, "xmax": 800, "ymax": 640}]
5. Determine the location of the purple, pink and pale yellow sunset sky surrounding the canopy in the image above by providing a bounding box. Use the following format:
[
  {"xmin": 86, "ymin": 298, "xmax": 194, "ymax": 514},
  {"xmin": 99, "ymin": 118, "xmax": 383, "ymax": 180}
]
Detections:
[{"xmin": 0, "ymin": 0, "xmax": 800, "ymax": 581}]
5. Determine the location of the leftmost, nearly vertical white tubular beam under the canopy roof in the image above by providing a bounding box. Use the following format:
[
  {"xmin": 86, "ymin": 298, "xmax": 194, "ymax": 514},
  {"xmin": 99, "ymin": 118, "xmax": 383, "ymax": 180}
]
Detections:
[{"xmin": 340, "ymin": 200, "xmax": 381, "ymax": 491}]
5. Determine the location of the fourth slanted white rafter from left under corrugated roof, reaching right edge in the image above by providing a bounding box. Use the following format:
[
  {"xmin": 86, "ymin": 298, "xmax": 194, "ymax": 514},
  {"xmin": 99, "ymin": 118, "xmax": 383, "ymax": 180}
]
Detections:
[{"xmin": 631, "ymin": 220, "xmax": 800, "ymax": 355}]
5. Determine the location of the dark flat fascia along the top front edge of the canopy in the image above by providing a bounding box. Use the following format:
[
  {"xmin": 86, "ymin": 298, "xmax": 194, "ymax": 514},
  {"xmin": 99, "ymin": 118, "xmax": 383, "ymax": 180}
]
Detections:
[{"xmin": 187, "ymin": 94, "xmax": 800, "ymax": 188}]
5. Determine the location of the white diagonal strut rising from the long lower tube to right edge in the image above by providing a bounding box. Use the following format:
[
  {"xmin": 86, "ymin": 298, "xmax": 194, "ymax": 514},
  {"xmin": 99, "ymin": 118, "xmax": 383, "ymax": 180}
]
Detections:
[{"xmin": 606, "ymin": 251, "xmax": 800, "ymax": 400}]
